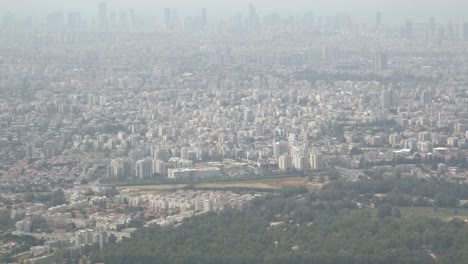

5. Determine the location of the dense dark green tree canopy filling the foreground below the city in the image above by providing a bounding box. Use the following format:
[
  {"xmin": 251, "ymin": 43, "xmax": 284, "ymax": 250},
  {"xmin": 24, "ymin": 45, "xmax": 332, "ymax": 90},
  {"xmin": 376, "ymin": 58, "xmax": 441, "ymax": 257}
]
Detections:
[{"xmin": 90, "ymin": 178, "xmax": 468, "ymax": 264}]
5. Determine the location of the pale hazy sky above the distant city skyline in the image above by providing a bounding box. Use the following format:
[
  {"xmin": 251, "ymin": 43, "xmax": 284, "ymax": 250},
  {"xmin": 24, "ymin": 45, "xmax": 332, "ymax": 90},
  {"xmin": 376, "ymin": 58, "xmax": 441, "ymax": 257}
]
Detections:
[{"xmin": 0, "ymin": 0, "xmax": 468, "ymax": 21}]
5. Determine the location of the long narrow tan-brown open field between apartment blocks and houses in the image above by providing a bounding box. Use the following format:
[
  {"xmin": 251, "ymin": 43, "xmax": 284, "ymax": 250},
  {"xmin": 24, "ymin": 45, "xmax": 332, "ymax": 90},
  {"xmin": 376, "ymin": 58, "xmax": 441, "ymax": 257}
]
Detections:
[{"xmin": 117, "ymin": 177, "xmax": 323, "ymax": 192}]
